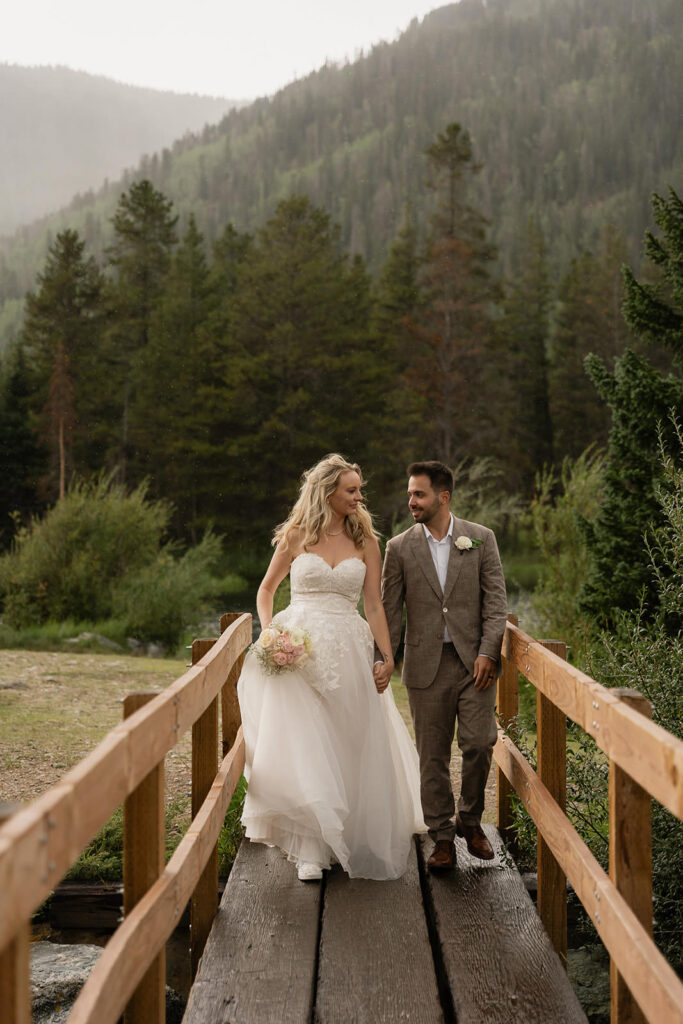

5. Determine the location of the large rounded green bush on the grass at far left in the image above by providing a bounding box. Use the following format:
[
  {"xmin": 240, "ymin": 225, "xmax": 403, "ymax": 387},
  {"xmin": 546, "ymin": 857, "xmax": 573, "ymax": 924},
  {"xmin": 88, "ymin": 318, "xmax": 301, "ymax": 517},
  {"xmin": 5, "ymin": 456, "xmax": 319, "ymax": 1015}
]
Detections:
[{"xmin": 0, "ymin": 478, "xmax": 220, "ymax": 646}]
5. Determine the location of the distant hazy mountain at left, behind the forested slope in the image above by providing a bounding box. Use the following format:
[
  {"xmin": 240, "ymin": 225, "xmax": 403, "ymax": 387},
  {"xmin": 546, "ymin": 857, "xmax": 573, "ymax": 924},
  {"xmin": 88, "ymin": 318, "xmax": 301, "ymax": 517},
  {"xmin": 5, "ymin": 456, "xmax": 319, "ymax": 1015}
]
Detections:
[{"xmin": 0, "ymin": 63, "xmax": 245, "ymax": 234}]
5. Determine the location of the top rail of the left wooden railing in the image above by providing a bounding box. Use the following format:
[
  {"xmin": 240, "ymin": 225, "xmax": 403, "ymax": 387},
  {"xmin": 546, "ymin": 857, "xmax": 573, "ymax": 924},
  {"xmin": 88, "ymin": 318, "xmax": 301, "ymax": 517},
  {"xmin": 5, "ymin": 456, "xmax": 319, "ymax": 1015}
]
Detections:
[{"xmin": 0, "ymin": 614, "xmax": 251, "ymax": 952}]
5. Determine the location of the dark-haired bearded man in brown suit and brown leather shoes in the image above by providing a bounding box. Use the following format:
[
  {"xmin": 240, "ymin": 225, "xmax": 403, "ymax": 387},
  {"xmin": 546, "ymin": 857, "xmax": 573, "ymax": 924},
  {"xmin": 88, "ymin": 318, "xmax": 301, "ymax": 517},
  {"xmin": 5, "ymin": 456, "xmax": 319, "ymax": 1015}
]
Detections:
[{"xmin": 382, "ymin": 462, "xmax": 507, "ymax": 871}]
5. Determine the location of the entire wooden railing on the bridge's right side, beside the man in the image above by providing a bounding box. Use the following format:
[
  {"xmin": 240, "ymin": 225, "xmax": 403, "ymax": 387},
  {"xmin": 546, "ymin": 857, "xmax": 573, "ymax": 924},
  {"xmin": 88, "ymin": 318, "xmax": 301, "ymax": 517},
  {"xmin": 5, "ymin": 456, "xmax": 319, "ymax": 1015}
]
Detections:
[{"xmin": 494, "ymin": 616, "xmax": 683, "ymax": 1024}]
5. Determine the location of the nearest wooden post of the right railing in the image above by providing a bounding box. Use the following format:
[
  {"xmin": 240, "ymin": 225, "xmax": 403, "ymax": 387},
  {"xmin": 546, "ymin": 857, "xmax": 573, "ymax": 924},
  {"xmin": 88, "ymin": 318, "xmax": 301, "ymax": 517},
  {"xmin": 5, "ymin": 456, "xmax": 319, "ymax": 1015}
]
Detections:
[{"xmin": 609, "ymin": 689, "xmax": 652, "ymax": 1024}]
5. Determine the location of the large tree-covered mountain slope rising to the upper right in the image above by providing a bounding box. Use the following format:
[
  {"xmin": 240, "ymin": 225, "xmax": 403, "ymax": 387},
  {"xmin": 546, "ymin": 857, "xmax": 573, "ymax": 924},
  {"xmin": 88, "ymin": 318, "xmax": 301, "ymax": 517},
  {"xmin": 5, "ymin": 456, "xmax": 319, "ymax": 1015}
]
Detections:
[{"xmin": 0, "ymin": 0, "xmax": 683, "ymax": 330}]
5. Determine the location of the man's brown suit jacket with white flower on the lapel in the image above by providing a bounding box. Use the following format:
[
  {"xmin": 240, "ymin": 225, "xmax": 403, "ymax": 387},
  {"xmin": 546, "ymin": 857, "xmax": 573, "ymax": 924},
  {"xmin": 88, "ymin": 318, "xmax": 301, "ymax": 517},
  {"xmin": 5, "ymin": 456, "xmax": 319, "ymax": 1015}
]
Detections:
[{"xmin": 382, "ymin": 516, "xmax": 507, "ymax": 687}]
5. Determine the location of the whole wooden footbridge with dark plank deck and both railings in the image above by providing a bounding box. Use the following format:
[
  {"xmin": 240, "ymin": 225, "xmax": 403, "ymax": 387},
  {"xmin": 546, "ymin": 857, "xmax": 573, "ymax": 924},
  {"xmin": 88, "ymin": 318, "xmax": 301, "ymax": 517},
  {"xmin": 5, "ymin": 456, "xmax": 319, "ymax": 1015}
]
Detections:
[{"xmin": 0, "ymin": 615, "xmax": 683, "ymax": 1024}]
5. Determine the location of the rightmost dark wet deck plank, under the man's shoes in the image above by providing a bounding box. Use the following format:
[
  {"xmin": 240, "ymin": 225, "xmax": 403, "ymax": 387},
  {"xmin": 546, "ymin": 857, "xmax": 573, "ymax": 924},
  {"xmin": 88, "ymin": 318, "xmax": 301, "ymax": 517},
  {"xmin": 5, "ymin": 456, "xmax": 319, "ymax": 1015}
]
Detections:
[{"xmin": 421, "ymin": 825, "xmax": 586, "ymax": 1024}]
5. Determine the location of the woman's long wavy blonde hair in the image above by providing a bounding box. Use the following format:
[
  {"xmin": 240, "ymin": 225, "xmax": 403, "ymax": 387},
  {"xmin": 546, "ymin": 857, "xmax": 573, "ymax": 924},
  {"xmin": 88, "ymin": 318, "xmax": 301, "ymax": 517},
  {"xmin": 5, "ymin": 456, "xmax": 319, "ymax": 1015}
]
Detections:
[{"xmin": 272, "ymin": 453, "xmax": 377, "ymax": 548}]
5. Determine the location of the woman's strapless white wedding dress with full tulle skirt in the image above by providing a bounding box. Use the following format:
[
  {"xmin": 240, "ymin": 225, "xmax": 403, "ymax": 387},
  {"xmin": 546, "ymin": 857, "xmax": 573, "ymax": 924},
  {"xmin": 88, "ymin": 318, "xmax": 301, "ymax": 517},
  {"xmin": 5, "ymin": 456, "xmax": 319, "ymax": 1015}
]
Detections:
[{"xmin": 238, "ymin": 552, "xmax": 426, "ymax": 879}]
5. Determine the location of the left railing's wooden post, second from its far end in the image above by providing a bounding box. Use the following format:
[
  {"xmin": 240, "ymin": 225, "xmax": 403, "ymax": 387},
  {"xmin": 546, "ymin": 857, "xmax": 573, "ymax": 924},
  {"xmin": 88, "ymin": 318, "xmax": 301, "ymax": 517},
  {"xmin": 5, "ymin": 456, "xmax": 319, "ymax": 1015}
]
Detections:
[{"xmin": 189, "ymin": 640, "xmax": 218, "ymax": 981}]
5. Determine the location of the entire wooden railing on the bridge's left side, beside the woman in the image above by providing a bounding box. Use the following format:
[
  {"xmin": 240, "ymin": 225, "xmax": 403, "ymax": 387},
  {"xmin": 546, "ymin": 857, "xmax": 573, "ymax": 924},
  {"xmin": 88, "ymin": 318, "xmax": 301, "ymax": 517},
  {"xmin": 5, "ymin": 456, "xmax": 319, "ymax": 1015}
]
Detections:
[{"xmin": 0, "ymin": 614, "xmax": 251, "ymax": 1024}]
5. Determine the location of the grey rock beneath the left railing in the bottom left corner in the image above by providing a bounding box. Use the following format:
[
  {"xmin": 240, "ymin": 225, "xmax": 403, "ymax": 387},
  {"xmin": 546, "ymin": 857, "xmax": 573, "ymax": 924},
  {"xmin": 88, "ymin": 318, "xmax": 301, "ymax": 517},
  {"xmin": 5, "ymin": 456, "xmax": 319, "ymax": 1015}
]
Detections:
[{"xmin": 31, "ymin": 942, "xmax": 185, "ymax": 1024}]
